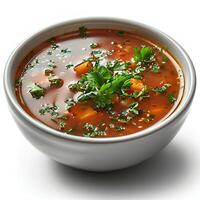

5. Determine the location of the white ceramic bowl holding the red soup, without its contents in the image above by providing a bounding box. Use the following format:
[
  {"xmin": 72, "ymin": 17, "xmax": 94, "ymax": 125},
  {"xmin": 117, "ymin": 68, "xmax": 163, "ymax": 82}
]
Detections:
[{"xmin": 4, "ymin": 18, "xmax": 196, "ymax": 171}]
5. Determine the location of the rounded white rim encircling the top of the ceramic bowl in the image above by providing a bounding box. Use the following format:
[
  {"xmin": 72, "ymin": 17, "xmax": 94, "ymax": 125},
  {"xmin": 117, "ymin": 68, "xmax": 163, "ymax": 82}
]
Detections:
[{"xmin": 3, "ymin": 17, "xmax": 196, "ymax": 143}]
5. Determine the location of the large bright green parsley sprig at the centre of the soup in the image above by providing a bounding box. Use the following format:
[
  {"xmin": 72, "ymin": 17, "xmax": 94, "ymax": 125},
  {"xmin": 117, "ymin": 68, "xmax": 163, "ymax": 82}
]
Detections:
[{"xmin": 69, "ymin": 58, "xmax": 134, "ymax": 110}]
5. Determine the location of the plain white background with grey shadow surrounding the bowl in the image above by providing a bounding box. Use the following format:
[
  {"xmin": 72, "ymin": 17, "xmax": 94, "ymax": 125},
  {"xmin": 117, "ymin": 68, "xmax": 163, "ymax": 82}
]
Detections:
[{"xmin": 0, "ymin": 0, "xmax": 200, "ymax": 200}]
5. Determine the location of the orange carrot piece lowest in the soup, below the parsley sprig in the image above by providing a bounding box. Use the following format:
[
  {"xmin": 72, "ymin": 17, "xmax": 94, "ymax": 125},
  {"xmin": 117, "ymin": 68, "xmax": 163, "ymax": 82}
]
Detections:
[{"xmin": 70, "ymin": 104, "xmax": 97, "ymax": 120}]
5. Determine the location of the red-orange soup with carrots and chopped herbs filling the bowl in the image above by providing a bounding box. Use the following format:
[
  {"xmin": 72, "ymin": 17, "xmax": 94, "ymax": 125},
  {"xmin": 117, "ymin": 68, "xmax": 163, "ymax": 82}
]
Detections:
[{"xmin": 15, "ymin": 26, "xmax": 183, "ymax": 137}]
